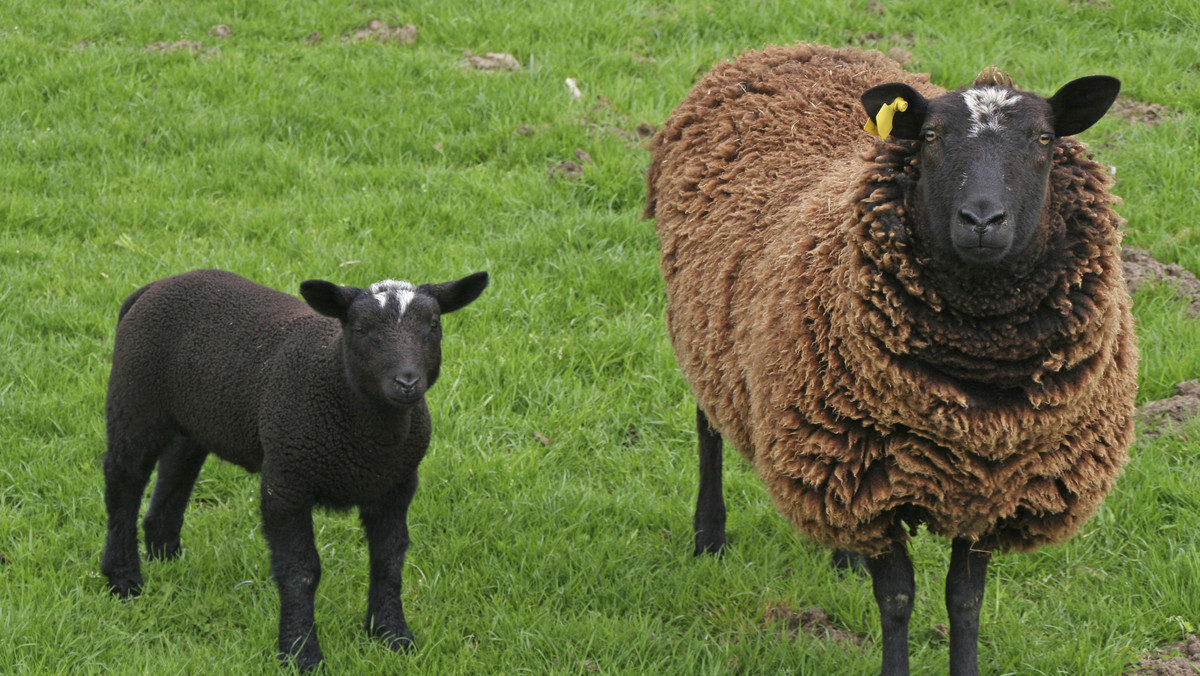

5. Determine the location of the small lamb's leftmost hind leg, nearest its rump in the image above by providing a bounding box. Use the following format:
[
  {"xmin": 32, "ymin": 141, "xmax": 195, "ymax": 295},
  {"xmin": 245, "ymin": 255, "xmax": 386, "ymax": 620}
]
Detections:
[{"xmin": 100, "ymin": 427, "xmax": 167, "ymax": 598}]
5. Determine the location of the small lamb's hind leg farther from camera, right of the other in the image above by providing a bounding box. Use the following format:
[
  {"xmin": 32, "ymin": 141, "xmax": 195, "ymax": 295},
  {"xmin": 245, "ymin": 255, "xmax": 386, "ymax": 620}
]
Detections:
[{"xmin": 142, "ymin": 437, "xmax": 208, "ymax": 558}]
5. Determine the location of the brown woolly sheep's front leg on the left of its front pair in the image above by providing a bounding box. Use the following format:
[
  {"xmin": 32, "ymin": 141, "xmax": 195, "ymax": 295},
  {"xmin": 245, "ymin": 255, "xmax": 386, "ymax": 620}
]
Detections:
[{"xmin": 866, "ymin": 540, "xmax": 916, "ymax": 676}]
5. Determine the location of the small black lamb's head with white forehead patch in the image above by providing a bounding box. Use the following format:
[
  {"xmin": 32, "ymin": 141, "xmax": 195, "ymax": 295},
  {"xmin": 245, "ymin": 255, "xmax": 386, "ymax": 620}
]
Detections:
[{"xmin": 300, "ymin": 273, "xmax": 487, "ymax": 408}]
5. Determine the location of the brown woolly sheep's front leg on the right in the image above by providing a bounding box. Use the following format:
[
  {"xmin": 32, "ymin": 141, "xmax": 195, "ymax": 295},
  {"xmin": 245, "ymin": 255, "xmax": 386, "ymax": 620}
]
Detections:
[{"xmin": 946, "ymin": 538, "xmax": 991, "ymax": 676}]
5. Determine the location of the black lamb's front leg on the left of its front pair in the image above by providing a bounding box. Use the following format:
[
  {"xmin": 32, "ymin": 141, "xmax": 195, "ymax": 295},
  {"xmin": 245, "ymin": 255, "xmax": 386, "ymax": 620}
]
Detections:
[{"xmin": 262, "ymin": 487, "xmax": 323, "ymax": 670}]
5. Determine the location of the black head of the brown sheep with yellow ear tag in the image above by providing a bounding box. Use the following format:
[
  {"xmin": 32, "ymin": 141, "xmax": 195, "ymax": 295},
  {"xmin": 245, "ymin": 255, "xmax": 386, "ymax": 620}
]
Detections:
[{"xmin": 863, "ymin": 70, "xmax": 1121, "ymax": 274}]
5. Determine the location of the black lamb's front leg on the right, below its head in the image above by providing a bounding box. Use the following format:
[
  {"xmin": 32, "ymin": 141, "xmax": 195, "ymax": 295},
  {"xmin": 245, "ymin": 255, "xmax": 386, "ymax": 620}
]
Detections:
[{"xmin": 359, "ymin": 471, "xmax": 416, "ymax": 651}]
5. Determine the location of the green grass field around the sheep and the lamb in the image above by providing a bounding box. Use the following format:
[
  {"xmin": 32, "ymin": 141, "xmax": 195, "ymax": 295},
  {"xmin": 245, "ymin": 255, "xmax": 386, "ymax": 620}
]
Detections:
[{"xmin": 0, "ymin": 0, "xmax": 1200, "ymax": 675}]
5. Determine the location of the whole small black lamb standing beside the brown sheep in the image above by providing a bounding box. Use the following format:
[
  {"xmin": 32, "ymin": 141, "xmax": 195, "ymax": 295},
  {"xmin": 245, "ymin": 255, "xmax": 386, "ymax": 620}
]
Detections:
[{"xmin": 101, "ymin": 270, "xmax": 487, "ymax": 669}]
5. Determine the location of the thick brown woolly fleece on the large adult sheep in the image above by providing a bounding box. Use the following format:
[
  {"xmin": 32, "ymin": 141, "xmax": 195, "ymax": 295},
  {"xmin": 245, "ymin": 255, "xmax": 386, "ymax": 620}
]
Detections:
[{"xmin": 646, "ymin": 44, "xmax": 1138, "ymax": 555}]
